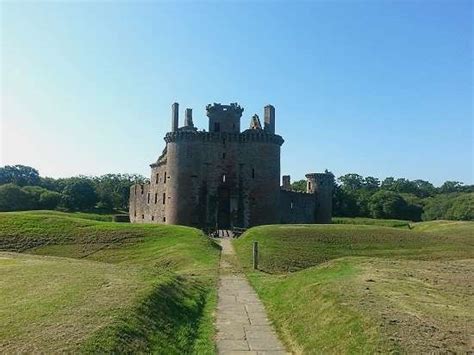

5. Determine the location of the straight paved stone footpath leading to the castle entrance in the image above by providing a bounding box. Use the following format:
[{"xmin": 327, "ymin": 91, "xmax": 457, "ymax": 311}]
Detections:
[{"xmin": 216, "ymin": 238, "xmax": 287, "ymax": 355}]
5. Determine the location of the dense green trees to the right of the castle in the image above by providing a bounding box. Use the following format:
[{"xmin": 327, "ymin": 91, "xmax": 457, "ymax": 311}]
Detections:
[{"xmin": 292, "ymin": 174, "xmax": 474, "ymax": 221}]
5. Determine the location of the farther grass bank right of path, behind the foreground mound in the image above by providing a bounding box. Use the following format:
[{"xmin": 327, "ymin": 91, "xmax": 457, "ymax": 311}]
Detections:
[{"xmin": 235, "ymin": 222, "xmax": 474, "ymax": 273}]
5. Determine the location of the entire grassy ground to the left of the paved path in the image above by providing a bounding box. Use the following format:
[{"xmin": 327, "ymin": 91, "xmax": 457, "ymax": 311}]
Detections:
[{"xmin": 0, "ymin": 211, "xmax": 219, "ymax": 353}]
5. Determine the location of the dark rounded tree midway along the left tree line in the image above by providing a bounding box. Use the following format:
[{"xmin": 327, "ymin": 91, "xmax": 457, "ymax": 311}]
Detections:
[{"xmin": 61, "ymin": 177, "xmax": 97, "ymax": 210}]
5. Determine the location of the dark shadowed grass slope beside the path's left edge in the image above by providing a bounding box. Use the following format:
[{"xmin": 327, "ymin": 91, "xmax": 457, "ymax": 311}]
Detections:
[{"xmin": 81, "ymin": 275, "xmax": 213, "ymax": 354}]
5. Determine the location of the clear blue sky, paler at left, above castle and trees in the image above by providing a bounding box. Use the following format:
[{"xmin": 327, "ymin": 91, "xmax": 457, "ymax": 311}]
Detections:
[{"xmin": 0, "ymin": 0, "xmax": 474, "ymax": 185}]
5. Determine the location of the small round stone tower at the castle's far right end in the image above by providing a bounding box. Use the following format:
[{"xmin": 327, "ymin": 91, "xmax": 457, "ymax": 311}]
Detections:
[{"xmin": 305, "ymin": 173, "xmax": 334, "ymax": 223}]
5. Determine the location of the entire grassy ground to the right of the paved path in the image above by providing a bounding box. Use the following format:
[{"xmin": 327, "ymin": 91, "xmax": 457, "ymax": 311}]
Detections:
[{"xmin": 234, "ymin": 222, "xmax": 474, "ymax": 353}]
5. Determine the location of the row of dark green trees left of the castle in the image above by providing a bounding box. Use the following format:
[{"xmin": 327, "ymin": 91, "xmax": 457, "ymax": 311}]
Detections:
[{"xmin": 0, "ymin": 165, "xmax": 146, "ymax": 212}]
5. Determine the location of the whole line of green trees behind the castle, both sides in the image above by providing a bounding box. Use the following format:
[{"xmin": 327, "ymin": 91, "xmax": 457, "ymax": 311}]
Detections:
[{"xmin": 0, "ymin": 165, "xmax": 474, "ymax": 221}]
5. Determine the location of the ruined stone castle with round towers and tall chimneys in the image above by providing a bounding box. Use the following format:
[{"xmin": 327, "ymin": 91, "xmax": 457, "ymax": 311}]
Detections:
[{"xmin": 130, "ymin": 103, "xmax": 333, "ymax": 229}]
